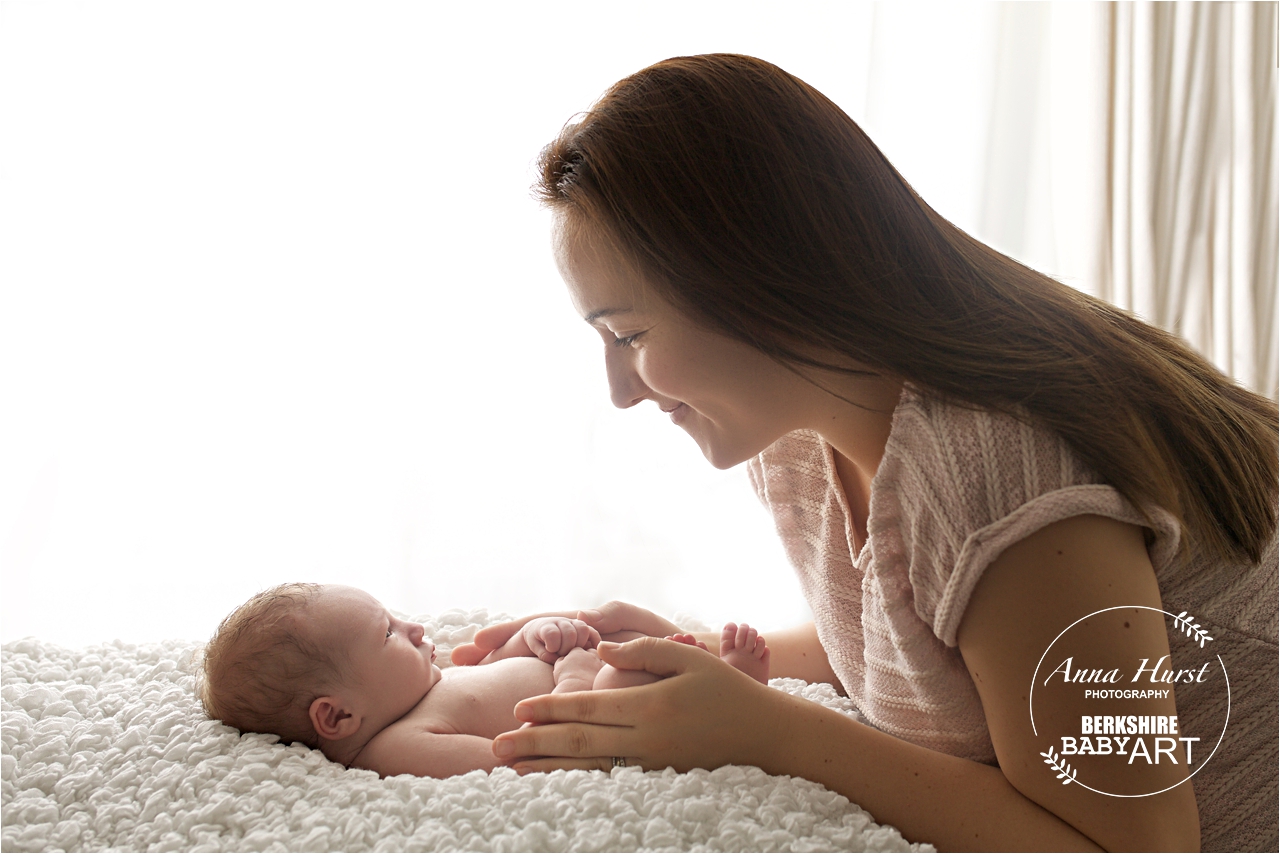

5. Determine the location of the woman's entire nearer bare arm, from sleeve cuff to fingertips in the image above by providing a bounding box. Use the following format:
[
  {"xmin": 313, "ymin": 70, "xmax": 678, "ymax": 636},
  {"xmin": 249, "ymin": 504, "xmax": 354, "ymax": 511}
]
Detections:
[{"xmin": 494, "ymin": 517, "xmax": 1198, "ymax": 850}]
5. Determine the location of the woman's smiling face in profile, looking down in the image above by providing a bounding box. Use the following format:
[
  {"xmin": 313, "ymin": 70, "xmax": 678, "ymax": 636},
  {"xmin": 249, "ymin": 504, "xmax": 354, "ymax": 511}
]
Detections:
[{"xmin": 556, "ymin": 220, "xmax": 808, "ymax": 469}]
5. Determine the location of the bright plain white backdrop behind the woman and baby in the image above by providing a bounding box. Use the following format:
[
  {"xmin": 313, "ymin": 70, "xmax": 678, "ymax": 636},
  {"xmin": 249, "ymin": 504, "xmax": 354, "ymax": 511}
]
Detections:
[{"xmin": 0, "ymin": 0, "xmax": 1034, "ymax": 644}]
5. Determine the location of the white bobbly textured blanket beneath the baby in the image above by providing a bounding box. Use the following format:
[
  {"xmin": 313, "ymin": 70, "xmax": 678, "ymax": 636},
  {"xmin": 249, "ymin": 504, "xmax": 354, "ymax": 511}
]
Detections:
[{"xmin": 0, "ymin": 611, "xmax": 933, "ymax": 851}]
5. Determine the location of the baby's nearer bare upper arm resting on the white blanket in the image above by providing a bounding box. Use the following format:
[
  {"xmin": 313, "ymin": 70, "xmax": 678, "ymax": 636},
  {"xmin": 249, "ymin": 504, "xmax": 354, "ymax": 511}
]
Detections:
[{"xmin": 351, "ymin": 725, "xmax": 502, "ymax": 778}]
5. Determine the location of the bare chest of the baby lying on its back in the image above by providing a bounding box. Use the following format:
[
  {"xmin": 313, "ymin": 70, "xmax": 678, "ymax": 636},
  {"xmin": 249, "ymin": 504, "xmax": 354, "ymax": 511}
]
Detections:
[{"xmin": 388, "ymin": 658, "xmax": 556, "ymax": 739}]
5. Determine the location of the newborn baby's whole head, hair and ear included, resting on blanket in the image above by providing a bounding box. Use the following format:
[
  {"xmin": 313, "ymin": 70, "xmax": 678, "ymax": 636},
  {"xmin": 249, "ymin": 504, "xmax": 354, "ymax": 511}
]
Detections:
[{"xmin": 201, "ymin": 584, "xmax": 440, "ymax": 753}]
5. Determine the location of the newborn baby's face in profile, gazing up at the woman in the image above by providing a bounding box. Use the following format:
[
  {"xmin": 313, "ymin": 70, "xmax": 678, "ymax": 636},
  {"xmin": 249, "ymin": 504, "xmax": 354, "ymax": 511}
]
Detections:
[{"xmin": 308, "ymin": 586, "xmax": 440, "ymax": 726}]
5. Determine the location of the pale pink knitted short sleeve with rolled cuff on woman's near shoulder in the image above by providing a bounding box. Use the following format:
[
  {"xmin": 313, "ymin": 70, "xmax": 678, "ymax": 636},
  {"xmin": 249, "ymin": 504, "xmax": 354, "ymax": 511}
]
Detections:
[{"xmin": 869, "ymin": 392, "xmax": 1180, "ymax": 647}]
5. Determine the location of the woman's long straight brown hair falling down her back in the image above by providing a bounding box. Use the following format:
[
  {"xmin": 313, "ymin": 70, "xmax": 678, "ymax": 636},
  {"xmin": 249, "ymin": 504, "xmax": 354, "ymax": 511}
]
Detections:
[{"xmin": 535, "ymin": 54, "xmax": 1277, "ymax": 562}]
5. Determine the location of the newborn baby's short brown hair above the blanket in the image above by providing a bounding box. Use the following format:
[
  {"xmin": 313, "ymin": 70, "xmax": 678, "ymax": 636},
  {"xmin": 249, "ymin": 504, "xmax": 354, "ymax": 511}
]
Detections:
[{"xmin": 200, "ymin": 584, "xmax": 344, "ymax": 748}]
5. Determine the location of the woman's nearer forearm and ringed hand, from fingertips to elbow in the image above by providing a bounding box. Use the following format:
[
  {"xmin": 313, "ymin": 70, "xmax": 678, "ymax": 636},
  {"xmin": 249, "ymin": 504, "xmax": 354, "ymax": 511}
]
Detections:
[{"xmin": 494, "ymin": 638, "xmax": 1098, "ymax": 850}]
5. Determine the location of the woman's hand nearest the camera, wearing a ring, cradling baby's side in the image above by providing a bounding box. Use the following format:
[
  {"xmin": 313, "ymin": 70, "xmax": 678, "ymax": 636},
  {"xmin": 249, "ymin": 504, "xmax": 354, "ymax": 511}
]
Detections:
[{"xmin": 494, "ymin": 638, "xmax": 791, "ymax": 773}]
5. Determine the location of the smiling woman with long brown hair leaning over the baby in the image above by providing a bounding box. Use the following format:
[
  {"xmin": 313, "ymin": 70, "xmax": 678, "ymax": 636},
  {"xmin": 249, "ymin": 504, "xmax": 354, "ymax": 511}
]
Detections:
[{"xmin": 456, "ymin": 55, "xmax": 1277, "ymax": 850}]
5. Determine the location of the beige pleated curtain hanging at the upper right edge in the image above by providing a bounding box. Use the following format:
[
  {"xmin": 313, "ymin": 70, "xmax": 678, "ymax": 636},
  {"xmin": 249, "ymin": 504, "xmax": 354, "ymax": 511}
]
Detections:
[{"xmin": 1100, "ymin": 3, "xmax": 1276, "ymax": 398}]
